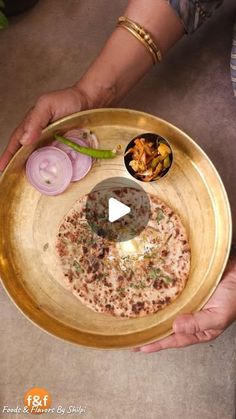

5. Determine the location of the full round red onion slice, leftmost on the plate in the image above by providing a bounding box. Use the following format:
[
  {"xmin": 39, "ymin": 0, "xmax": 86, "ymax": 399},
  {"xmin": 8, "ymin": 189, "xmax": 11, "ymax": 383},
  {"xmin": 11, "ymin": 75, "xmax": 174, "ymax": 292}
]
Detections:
[{"xmin": 26, "ymin": 146, "xmax": 73, "ymax": 195}]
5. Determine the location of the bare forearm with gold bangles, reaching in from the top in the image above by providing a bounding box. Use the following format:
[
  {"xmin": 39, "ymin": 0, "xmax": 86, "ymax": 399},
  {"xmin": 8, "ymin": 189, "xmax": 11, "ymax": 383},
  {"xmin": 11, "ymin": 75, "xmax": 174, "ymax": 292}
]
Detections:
[{"xmin": 77, "ymin": 0, "xmax": 184, "ymax": 108}]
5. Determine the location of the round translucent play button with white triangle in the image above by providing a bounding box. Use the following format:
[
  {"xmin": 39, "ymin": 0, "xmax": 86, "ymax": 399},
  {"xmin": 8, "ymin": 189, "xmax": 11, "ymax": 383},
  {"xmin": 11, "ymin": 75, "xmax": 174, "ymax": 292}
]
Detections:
[{"xmin": 85, "ymin": 177, "xmax": 151, "ymax": 243}]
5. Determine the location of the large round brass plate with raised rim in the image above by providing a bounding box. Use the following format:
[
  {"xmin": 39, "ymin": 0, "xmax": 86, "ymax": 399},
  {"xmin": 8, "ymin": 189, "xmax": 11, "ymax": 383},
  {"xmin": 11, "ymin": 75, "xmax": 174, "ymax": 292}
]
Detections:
[{"xmin": 0, "ymin": 109, "xmax": 232, "ymax": 349}]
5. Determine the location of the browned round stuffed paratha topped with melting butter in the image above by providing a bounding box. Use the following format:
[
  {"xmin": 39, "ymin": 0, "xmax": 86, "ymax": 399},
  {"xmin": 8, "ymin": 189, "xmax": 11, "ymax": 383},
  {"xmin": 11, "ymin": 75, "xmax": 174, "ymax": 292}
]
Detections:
[{"xmin": 56, "ymin": 188, "xmax": 190, "ymax": 318}]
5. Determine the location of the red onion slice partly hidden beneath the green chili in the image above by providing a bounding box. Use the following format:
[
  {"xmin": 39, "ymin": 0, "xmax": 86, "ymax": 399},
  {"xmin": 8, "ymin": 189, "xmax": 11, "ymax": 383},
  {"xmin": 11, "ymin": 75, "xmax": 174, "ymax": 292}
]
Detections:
[{"xmin": 52, "ymin": 134, "xmax": 93, "ymax": 182}]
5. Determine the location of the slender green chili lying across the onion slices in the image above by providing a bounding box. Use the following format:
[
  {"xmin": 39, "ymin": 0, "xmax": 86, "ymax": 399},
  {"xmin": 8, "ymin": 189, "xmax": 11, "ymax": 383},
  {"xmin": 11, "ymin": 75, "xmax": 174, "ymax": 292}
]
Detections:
[{"xmin": 54, "ymin": 134, "xmax": 117, "ymax": 159}]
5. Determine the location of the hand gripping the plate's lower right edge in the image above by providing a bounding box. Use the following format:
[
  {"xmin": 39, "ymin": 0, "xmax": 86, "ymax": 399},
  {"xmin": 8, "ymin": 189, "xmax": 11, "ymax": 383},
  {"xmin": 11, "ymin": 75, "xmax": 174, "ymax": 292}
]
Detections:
[{"xmin": 133, "ymin": 253, "xmax": 236, "ymax": 353}]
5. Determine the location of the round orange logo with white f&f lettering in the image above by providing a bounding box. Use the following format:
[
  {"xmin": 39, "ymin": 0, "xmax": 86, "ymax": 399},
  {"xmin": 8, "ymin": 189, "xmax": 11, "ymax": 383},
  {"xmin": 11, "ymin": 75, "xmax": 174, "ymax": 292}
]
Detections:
[{"xmin": 24, "ymin": 387, "xmax": 52, "ymax": 414}]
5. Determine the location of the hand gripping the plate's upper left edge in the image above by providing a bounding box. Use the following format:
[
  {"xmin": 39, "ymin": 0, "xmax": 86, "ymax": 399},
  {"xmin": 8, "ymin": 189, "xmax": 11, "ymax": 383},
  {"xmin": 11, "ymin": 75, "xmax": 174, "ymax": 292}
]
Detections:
[{"xmin": 0, "ymin": 87, "xmax": 89, "ymax": 171}]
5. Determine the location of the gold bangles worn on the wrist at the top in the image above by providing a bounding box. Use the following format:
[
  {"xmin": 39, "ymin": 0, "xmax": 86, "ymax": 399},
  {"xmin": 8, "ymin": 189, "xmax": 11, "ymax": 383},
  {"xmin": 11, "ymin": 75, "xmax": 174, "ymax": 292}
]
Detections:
[{"xmin": 117, "ymin": 16, "xmax": 162, "ymax": 64}]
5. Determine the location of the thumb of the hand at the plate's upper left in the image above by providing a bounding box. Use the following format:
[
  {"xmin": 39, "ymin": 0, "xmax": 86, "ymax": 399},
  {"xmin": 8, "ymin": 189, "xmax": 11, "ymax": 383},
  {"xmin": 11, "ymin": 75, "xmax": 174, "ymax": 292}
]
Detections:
[{"xmin": 19, "ymin": 95, "xmax": 52, "ymax": 144}]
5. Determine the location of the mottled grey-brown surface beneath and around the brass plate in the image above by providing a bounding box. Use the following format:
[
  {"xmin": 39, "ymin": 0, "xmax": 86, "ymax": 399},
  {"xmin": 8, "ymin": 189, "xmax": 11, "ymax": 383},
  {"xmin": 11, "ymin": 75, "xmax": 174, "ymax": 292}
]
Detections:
[{"xmin": 0, "ymin": 0, "xmax": 236, "ymax": 419}]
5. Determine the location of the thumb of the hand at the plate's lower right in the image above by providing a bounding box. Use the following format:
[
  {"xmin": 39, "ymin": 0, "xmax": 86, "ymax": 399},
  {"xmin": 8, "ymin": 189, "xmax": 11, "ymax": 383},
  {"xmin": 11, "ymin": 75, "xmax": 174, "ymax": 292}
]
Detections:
[{"xmin": 173, "ymin": 310, "xmax": 220, "ymax": 335}]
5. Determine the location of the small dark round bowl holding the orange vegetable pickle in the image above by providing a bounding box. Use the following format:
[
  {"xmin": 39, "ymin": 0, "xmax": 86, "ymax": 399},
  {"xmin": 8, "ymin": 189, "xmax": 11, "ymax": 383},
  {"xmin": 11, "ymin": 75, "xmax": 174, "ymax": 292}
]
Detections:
[{"xmin": 124, "ymin": 132, "xmax": 173, "ymax": 182}]
